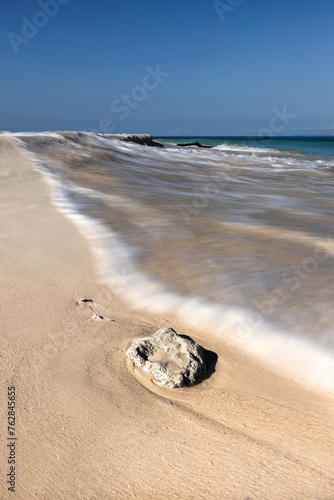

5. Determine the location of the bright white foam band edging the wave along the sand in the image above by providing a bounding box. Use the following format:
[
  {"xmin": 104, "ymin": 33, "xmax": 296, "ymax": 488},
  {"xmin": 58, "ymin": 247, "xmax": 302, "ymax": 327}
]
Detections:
[{"xmin": 37, "ymin": 166, "xmax": 334, "ymax": 395}]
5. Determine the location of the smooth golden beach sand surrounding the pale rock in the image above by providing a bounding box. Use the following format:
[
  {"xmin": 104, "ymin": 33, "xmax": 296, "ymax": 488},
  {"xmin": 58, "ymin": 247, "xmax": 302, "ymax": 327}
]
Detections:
[{"xmin": 0, "ymin": 137, "xmax": 334, "ymax": 500}]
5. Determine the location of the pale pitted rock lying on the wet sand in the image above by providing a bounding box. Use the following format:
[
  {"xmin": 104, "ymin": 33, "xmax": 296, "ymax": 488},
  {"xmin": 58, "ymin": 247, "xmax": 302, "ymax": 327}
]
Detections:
[{"xmin": 126, "ymin": 328, "xmax": 206, "ymax": 388}]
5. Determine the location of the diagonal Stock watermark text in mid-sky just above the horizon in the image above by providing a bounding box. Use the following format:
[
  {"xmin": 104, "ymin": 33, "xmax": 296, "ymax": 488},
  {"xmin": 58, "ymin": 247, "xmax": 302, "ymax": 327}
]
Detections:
[{"xmin": 91, "ymin": 64, "xmax": 169, "ymax": 134}]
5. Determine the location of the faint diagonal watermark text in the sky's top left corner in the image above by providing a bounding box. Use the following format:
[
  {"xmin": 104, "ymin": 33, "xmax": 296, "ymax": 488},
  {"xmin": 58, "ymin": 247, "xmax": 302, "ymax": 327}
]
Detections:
[{"xmin": 7, "ymin": 0, "xmax": 70, "ymax": 54}]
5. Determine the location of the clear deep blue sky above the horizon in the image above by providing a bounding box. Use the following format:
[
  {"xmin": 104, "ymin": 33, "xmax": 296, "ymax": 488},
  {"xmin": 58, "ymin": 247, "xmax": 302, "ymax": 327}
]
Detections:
[{"xmin": 0, "ymin": 0, "xmax": 334, "ymax": 136}]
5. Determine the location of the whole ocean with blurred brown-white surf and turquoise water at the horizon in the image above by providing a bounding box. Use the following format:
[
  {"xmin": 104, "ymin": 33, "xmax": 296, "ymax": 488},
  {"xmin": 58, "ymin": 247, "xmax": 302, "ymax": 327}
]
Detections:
[{"xmin": 6, "ymin": 132, "xmax": 334, "ymax": 392}]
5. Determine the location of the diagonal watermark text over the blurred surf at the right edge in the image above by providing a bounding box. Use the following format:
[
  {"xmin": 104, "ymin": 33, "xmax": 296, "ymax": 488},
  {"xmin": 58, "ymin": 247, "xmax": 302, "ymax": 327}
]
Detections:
[{"xmin": 237, "ymin": 236, "xmax": 334, "ymax": 341}]
